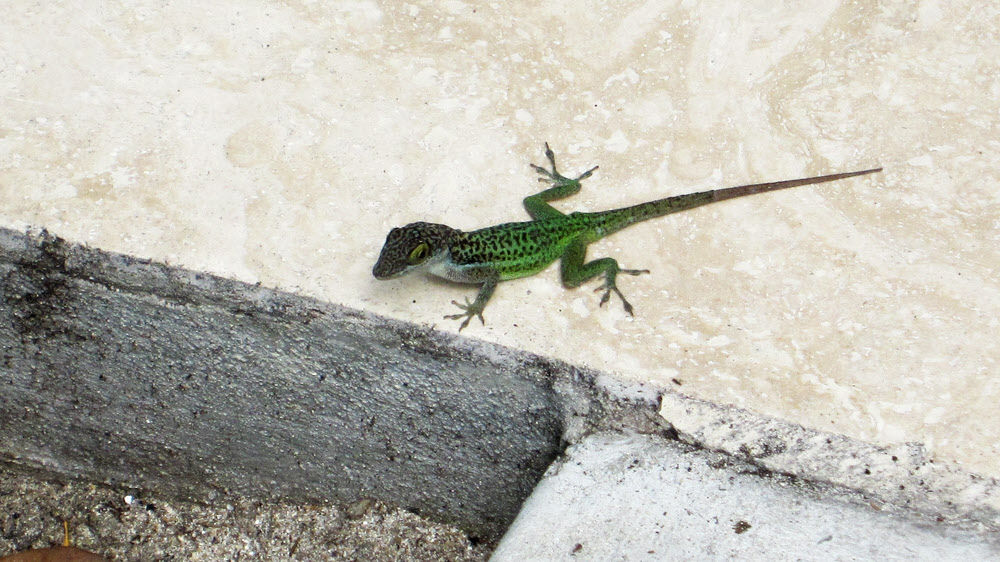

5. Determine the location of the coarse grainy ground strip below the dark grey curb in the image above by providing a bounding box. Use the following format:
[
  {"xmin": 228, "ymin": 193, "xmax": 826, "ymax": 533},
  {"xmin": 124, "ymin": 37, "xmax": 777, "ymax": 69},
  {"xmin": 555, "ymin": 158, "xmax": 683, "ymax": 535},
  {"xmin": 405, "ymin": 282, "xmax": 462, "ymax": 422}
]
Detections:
[{"xmin": 0, "ymin": 465, "xmax": 491, "ymax": 562}]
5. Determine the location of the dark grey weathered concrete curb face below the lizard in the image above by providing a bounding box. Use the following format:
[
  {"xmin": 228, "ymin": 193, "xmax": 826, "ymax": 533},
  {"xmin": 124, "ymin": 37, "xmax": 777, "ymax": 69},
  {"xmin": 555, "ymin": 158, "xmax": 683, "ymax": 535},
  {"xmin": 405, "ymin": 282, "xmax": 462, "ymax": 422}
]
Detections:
[{"xmin": 0, "ymin": 224, "xmax": 656, "ymax": 540}]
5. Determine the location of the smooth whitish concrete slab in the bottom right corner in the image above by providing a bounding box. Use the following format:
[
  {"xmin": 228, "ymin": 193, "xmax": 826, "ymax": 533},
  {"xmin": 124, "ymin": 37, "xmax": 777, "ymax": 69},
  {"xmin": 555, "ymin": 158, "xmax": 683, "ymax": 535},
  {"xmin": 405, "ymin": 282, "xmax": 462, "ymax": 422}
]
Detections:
[{"xmin": 491, "ymin": 434, "xmax": 1000, "ymax": 562}]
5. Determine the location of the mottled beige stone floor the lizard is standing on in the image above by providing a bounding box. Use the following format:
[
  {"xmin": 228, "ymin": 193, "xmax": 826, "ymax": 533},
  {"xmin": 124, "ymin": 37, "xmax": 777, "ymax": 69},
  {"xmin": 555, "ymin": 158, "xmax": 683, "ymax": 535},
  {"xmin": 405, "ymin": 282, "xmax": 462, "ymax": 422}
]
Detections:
[{"xmin": 0, "ymin": 0, "xmax": 1000, "ymax": 476}]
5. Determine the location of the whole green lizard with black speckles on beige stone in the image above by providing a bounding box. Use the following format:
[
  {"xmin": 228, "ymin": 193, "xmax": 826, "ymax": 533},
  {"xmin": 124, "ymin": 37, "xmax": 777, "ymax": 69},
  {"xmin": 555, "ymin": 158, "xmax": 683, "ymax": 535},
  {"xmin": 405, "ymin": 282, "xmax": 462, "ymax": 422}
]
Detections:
[{"xmin": 372, "ymin": 143, "xmax": 882, "ymax": 331}]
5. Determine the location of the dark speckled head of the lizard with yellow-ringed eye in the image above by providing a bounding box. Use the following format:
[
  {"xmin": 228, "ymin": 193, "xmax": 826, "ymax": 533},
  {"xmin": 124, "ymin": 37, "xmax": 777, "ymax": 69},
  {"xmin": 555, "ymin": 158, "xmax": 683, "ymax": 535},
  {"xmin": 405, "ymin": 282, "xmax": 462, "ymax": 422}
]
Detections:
[{"xmin": 372, "ymin": 222, "xmax": 460, "ymax": 279}]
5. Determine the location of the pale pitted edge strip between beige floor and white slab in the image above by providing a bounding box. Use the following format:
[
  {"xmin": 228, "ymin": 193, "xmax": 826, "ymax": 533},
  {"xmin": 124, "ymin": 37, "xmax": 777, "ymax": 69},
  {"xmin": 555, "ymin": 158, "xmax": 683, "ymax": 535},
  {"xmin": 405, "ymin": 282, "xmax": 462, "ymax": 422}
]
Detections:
[{"xmin": 660, "ymin": 393, "xmax": 1000, "ymax": 532}]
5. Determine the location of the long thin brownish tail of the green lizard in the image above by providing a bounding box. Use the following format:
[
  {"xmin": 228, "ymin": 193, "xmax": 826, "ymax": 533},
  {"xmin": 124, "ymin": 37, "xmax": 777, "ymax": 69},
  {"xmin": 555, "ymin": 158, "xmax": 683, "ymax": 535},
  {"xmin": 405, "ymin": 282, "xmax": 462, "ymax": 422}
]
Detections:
[{"xmin": 588, "ymin": 168, "xmax": 882, "ymax": 238}]
